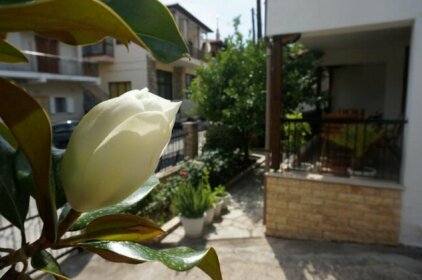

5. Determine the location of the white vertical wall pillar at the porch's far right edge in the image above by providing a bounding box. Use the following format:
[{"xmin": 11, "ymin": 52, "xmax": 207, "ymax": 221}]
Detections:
[{"xmin": 400, "ymin": 17, "xmax": 422, "ymax": 246}]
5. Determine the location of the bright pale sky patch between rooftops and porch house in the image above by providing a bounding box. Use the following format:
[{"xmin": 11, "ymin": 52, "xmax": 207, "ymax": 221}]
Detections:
[{"xmin": 162, "ymin": 0, "xmax": 264, "ymax": 39}]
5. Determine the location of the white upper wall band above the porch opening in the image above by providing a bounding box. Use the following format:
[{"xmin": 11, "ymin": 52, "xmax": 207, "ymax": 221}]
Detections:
[{"xmin": 266, "ymin": 0, "xmax": 422, "ymax": 36}]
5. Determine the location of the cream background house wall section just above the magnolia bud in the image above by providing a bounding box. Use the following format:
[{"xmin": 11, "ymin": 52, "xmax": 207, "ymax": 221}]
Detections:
[{"xmin": 99, "ymin": 43, "xmax": 148, "ymax": 92}]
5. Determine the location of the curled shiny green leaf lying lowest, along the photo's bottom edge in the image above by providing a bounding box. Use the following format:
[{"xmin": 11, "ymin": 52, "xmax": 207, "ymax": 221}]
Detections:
[{"xmin": 81, "ymin": 241, "xmax": 222, "ymax": 280}]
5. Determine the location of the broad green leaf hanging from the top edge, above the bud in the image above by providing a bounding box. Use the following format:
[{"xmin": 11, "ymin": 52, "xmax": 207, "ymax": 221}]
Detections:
[{"xmin": 104, "ymin": 0, "xmax": 189, "ymax": 63}]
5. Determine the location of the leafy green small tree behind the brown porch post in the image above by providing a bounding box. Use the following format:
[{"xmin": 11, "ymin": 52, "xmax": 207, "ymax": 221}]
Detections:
[{"xmin": 190, "ymin": 18, "xmax": 320, "ymax": 160}]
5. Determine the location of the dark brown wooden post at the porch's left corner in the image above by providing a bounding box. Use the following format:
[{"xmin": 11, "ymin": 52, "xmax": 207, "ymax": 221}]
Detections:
[{"xmin": 265, "ymin": 37, "xmax": 283, "ymax": 171}]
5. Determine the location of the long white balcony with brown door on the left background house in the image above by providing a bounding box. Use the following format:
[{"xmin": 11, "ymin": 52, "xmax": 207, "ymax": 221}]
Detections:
[{"xmin": 0, "ymin": 51, "xmax": 99, "ymax": 83}]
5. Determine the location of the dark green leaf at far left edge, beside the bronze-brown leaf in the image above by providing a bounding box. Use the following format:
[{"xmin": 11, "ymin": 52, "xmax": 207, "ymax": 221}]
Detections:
[{"xmin": 0, "ymin": 137, "xmax": 29, "ymax": 230}]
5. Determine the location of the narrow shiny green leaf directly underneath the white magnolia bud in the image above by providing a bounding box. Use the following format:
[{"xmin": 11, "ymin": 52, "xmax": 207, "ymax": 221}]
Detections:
[{"xmin": 67, "ymin": 176, "xmax": 160, "ymax": 231}]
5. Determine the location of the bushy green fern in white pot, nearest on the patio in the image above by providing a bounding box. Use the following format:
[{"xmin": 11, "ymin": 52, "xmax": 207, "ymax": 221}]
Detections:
[{"xmin": 173, "ymin": 181, "xmax": 208, "ymax": 238}]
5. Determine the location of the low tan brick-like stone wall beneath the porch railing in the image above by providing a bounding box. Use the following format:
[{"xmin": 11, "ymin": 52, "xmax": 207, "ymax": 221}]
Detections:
[{"xmin": 264, "ymin": 173, "xmax": 401, "ymax": 245}]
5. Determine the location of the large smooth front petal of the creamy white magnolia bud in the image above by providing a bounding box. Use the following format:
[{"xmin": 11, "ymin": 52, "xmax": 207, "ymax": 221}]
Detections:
[{"xmin": 67, "ymin": 112, "xmax": 171, "ymax": 212}]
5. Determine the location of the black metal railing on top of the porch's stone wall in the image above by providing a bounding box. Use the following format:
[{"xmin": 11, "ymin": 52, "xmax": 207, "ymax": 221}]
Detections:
[{"xmin": 281, "ymin": 119, "xmax": 406, "ymax": 182}]
